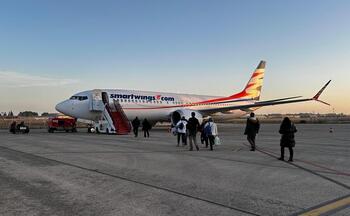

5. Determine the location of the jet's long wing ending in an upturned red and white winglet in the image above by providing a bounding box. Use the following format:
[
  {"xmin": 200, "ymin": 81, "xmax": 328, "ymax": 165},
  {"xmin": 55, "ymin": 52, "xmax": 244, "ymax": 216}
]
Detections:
[{"xmin": 201, "ymin": 80, "xmax": 331, "ymax": 115}]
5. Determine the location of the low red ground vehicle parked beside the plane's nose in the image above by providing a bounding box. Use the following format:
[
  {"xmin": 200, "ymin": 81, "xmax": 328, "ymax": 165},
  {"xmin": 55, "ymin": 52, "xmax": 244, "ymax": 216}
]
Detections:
[{"xmin": 47, "ymin": 116, "xmax": 77, "ymax": 133}]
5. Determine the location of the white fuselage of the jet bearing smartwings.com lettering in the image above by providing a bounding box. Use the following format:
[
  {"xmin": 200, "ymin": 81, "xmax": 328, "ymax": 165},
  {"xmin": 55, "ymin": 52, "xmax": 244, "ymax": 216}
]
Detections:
[{"xmin": 56, "ymin": 89, "xmax": 252, "ymax": 122}]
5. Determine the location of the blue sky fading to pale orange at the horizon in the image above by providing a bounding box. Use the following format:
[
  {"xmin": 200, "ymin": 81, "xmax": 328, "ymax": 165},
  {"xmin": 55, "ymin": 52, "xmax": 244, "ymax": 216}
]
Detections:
[{"xmin": 0, "ymin": 0, "xmax": 350, "ymax": 114}]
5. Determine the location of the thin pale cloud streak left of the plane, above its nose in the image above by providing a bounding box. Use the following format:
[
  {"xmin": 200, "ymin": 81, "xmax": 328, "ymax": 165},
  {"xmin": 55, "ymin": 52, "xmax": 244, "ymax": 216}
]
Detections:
[{"xmin": 0, "ymin": 71, "xmax": 79, "ymax": 87}]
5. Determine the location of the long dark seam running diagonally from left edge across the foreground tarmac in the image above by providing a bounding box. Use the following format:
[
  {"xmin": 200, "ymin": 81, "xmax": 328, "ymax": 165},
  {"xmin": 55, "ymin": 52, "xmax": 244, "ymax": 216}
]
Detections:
[{"xmin": 0, "ymin": 146, "xmax": 261, "ymax": 216}]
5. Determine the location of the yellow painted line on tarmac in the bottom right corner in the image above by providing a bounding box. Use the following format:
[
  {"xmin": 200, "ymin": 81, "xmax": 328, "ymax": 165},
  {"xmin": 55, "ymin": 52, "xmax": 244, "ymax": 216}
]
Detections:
[{"xmin": 292, "ymin": 195, "xmax": 350, "ymax": 216}]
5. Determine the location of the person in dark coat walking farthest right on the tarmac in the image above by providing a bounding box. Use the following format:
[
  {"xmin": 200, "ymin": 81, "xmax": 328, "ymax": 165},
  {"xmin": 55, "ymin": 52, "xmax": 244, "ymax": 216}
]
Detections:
[{"xmin": 278, "ymin": 117, "xmax": 297, "ymax": 162}]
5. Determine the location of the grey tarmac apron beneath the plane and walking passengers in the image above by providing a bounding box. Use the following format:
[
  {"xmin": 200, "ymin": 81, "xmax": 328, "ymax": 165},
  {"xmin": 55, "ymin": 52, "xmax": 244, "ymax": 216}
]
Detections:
[{"xmin": 0, "ymin": 124, "xmax": 350, "ymax": 216}]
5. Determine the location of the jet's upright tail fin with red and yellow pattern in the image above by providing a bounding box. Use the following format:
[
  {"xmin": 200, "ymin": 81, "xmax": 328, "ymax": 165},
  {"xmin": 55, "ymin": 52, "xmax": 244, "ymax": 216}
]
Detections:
[{"xmin": 230, "ymin": 61, "xmax": 266, "ymax": 100}]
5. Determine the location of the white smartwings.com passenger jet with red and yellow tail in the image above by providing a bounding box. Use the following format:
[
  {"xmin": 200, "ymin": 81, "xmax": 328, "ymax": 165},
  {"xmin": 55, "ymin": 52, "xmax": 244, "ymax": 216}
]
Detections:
[{"xmin": 55, "ymin": 61, "xmax": 331, "ymax": 133}]
